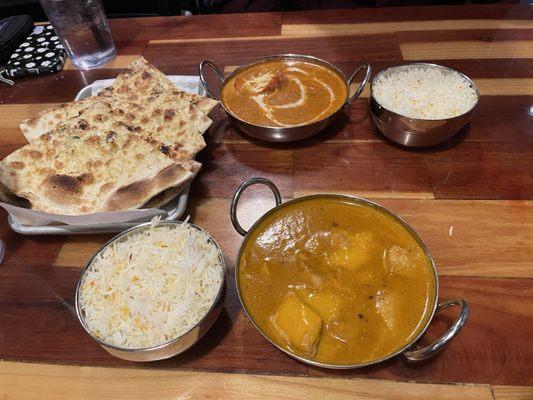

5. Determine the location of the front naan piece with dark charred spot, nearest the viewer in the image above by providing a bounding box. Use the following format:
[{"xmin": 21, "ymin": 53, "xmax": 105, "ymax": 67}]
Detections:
[{"xmin": 0, "ymin": 128, "xmax": 201, "ymax": 215}]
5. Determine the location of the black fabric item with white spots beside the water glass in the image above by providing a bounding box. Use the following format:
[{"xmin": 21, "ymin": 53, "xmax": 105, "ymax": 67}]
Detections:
[{"xmin": 5, "ymin": 25, "xmax": 66, "ymax": 78}]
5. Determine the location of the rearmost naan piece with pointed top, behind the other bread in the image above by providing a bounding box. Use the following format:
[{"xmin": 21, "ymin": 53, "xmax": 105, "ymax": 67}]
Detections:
[{"xmin": 20, "ymin": 57, "xmax": 218, "ymax": 142}]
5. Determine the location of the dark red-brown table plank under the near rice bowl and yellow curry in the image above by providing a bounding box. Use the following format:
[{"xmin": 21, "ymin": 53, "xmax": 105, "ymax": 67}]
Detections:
[{"xmin": 0, "ymin": 265, "xmax": 533, "ymax": 385}]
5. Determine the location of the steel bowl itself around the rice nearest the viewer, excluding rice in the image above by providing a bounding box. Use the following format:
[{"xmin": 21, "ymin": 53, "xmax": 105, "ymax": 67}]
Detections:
[{"xmin": 75, "ymin": 221, "xmax": 226, "ymax": 362}]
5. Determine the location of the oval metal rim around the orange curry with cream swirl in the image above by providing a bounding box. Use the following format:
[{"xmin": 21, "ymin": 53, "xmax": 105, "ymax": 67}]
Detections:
[{"xmin": 219, "ymin": 53, "xmax": 350, "ymax": 130}]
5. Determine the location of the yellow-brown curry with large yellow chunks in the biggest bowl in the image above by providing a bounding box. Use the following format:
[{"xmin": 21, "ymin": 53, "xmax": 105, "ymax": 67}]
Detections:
[{"xmin": 238, "ymin": 196, "xmax": 435, "ymax": 365}]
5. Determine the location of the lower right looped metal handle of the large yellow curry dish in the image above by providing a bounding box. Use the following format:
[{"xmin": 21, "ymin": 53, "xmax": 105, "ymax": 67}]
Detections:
[{"xmin": 403, "ymin": 299, "xmax": 469, "ymax": 361}]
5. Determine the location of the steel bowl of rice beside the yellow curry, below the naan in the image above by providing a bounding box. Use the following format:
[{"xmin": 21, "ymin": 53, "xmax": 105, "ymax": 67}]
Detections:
[{"xmin": 75, "ymin": 219, "xmax": 226, "ymax": 361}]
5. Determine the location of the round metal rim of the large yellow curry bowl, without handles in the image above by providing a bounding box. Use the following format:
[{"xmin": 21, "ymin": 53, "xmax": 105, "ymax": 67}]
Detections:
[{"xmin": 234, "ymin": 193, "xmax": 439, "ymax": 369}]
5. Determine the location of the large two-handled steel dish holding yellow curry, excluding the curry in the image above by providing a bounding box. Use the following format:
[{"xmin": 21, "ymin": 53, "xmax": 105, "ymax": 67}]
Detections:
[{"xmin": 230, "ymin": 178, "xmax": 468, "ymax": 369}]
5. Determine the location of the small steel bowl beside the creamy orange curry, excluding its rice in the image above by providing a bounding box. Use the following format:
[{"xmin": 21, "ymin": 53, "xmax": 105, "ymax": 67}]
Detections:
[{"xmin": 369, "ymin": 63, "xmax": 479, "ymax": 147}]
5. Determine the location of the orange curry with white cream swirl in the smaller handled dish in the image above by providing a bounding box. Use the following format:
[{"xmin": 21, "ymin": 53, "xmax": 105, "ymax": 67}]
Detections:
[{"xmin": 220, "ymin": 60, "xmax": 346, "ymax": 127}]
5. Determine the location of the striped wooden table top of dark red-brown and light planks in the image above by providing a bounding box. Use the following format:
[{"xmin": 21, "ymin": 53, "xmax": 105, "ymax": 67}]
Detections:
[{"xmin": 0, "ymin": 5, "xmax": 533, "ymax": 400}]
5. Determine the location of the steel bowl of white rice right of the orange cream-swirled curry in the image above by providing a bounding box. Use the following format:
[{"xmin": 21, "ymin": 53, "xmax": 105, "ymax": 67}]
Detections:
[{"xmin": 369, "ymin": 63, "xmax": 479, "ymax": 147}]
